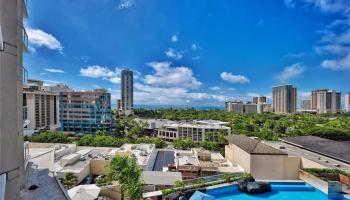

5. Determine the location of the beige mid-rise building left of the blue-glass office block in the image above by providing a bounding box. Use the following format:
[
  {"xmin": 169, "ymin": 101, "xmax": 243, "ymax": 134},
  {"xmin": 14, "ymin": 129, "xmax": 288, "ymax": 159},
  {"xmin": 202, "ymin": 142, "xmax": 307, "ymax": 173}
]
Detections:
[{"xmin": 23, "ymin": 80, "xmax": 60, "ymax": 135}]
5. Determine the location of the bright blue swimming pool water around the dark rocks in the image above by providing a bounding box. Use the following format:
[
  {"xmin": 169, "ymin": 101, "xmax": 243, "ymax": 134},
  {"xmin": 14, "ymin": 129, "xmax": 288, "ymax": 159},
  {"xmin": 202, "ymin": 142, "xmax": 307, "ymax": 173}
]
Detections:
[{"xmin": 206, "ymin": 183, "xmax": 345, "ymax": 200}]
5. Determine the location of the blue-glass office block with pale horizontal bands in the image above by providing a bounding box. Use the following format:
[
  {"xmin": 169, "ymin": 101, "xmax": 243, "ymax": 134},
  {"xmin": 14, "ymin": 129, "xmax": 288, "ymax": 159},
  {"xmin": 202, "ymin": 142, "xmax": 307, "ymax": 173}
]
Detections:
[{"xmin": 59, "ymin": 89, "xmax": 112, "ymax": 133}]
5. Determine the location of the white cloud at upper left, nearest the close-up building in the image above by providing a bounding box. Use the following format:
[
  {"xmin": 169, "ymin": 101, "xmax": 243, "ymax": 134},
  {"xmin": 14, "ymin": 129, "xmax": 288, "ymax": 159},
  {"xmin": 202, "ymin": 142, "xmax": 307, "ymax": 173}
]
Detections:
[{"xmin": 26, "ymin": 28, "xmax": 63, "ymax": 53}]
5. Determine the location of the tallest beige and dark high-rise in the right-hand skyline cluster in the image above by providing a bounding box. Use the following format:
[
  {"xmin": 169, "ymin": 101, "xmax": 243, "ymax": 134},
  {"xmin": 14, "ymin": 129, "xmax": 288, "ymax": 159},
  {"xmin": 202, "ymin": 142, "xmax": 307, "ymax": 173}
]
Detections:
[{"xmin": 272, "ymin": 85, "xmax": 297, "ymax": 114}]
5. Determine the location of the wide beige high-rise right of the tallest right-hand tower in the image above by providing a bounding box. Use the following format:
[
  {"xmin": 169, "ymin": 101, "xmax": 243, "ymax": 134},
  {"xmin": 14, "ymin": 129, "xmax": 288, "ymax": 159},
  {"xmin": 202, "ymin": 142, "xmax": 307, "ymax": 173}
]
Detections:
[{"xmin": 311, "ymin": 89, "xmax": 341, "ymax": 113}]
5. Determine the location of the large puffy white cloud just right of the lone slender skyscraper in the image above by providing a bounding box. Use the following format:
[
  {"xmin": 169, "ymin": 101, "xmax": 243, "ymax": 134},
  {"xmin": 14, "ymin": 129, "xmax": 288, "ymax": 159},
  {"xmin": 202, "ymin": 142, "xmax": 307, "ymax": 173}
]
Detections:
[{"xmin": 144, "ymin": 62, "xmax": 202, "ymax": 88}]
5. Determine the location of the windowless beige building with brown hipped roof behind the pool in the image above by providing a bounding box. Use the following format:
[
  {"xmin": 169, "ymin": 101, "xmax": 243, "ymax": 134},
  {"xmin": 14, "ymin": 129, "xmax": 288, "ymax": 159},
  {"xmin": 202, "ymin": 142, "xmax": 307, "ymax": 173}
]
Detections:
[{"xmin": 225, "ymin": 135, "xmax": 300, "ymax": 180}]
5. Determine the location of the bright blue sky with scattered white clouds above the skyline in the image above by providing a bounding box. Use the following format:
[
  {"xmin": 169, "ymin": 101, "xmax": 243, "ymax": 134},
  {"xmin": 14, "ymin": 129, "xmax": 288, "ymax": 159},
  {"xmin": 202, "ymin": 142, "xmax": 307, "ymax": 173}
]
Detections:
[{"xmin": 24, "ymin": 0, "xmax": 350, "ymax": 106}]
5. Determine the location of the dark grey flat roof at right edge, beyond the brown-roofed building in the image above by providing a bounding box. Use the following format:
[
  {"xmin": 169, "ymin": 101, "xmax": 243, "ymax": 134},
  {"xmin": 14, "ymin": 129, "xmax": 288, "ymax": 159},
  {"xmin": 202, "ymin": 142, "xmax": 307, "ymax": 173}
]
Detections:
[{"xmin": 281, "ymin": 136, "xmax": 350, "ymax": 164}]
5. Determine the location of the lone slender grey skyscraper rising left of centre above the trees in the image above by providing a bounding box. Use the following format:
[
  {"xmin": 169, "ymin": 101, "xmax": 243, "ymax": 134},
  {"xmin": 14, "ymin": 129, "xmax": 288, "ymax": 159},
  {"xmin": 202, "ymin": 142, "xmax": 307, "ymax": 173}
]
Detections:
[{"xmin": 119, "ymin": 69, "xmax": 134, "ymax": 116}]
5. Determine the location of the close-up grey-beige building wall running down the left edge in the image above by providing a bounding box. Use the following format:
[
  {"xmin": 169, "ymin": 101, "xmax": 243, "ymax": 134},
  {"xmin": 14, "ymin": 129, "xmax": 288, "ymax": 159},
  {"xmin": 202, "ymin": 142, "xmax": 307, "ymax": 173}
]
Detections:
[{"xmin": 0, "ymin": 0, "xmax": 28, "ymax": 200}]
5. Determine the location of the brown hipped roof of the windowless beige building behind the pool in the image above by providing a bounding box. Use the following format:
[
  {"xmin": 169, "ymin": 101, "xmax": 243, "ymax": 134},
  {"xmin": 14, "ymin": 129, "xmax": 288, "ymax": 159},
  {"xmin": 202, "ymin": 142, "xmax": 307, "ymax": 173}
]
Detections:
[{"xmin": 227, "ymin": 135, "xmax": 287, "ymax": 155}]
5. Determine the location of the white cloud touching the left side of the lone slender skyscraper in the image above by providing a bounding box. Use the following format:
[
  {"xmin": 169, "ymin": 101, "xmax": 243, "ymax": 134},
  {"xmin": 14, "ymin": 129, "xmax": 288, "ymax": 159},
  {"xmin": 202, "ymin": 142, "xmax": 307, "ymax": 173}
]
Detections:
[{"xmin": 80, "ymin": 65, "xmax": 121, "ymax": 83}]
